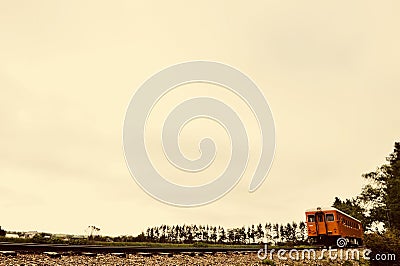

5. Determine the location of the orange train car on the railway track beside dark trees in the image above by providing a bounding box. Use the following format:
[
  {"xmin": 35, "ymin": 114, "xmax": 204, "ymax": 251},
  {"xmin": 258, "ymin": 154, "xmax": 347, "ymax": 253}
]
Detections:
[{"xmin": 306, "ymin": 207, "xmax": 364, "ymax": 246}]
